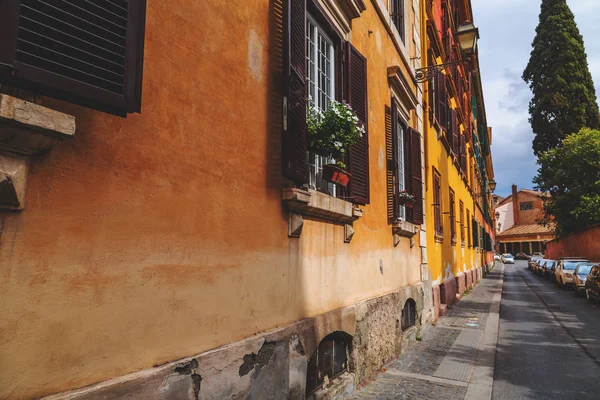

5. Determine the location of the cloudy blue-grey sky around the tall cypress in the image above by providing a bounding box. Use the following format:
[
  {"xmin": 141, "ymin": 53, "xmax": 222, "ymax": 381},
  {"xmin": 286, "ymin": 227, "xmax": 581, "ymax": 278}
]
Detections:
[{"xmin": 471, "ymin": 0, "xmax": 600, "ymax": 197}]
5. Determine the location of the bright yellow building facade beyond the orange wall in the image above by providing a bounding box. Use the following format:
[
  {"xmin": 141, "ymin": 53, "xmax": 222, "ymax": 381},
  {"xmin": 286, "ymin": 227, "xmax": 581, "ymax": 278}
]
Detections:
[{"xmin": 421, "ymin": 0, "xmax": 494, "ymax": 316}]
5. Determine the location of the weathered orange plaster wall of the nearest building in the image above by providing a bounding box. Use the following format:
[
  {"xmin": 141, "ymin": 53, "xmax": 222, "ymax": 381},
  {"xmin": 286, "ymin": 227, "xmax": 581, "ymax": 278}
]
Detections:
[{"xmin": 0, "ymin": 0, "xmax": 420, "ymax": 398}]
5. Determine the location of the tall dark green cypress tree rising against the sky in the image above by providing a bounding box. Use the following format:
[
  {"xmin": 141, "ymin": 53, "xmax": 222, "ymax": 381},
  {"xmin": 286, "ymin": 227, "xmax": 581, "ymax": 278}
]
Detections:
[{"xmin": 523, "ymin": 0, "xmax": 600, "ymax": 157}]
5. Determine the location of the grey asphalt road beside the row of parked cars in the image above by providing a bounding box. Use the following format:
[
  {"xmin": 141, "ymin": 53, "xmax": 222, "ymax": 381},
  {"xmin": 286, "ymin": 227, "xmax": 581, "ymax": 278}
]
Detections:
[{"xmin": 492, "ymin": 261, "xmax": 600, "ymax": 400}]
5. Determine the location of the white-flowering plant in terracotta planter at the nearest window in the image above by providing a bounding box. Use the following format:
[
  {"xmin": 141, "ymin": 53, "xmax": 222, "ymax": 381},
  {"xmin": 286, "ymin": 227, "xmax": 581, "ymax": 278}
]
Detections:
[{"xmin": 306, "ymin": 97, "xmax": 365, "ymax": 187}]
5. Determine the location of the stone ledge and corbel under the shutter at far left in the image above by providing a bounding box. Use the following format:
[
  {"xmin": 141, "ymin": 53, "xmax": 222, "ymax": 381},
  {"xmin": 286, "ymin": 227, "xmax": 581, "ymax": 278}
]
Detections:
[{"xmin": 0, "ymin": 94, "xmax": 75, "ymax": 210}]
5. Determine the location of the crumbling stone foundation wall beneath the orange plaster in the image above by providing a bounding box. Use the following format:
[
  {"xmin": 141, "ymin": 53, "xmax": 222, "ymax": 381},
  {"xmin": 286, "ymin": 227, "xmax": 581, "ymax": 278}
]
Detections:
[{"xmin": 46, "ymin": 284, "xmax": 426, "ymax": 400}]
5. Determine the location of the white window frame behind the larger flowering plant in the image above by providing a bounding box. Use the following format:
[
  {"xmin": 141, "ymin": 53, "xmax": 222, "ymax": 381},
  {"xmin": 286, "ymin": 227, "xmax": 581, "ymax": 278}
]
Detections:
[{"xmin": 306, "ymin": 14, "xmax": 336, "ymax": 196}]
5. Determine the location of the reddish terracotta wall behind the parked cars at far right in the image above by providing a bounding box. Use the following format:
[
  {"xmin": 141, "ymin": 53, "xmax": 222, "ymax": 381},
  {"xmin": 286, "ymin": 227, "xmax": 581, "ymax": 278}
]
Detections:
[{"xmin": 546, "ymin": 226, "xmax": 600, "ymax": 262}]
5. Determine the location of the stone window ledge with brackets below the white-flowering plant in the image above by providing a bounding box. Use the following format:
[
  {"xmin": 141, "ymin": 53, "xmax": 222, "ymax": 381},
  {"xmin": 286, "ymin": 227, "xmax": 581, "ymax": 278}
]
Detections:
[{"xmin": 282, "ymin": 188, "xmax": 362, "ymax": 242}]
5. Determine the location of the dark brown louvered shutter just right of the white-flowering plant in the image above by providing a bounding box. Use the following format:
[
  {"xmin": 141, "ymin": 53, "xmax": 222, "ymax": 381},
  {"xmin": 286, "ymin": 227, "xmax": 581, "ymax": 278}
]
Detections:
[{"xmin": 346, "ymin": 43, "xmax": 369, "ymax": 204}]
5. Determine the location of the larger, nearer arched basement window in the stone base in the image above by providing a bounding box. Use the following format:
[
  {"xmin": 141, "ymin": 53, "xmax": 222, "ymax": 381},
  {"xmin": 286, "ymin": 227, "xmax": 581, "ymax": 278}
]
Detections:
[{"xmin": 306, "ymin": 332, "xmax": 352, "ymax": 397}]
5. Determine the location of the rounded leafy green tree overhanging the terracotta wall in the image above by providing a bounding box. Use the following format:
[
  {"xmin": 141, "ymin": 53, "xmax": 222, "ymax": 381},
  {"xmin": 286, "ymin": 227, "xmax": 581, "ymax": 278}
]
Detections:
[{"xmin": 533, "ymin": 128, "xmax": 600, "ymax": 236}]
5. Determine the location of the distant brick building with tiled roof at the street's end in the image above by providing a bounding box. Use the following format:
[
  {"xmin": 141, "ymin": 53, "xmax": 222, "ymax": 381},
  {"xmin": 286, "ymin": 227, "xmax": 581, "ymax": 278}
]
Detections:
[{"xmin": 494, "ymin": 185, "xmax": 555, "ymax": 254}]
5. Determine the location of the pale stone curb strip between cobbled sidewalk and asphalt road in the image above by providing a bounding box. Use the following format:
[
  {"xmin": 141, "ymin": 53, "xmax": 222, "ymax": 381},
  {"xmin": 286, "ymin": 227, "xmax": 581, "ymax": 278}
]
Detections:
[{"xmin": 465, "ymin": 264, "xmax": 505, "ymax": 400}]
